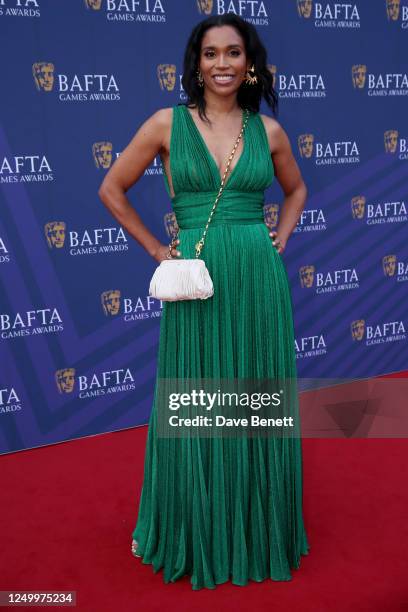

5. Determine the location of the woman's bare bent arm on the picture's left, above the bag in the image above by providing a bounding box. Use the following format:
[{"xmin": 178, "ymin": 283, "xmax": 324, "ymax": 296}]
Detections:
[{"xmin": 98, "ymin": 108, "xmax": 178, "ymax": 262}]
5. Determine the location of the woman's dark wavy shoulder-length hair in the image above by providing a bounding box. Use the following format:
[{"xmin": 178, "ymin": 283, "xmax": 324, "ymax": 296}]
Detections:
[{"xmin": 181, "ymin": 13, "xmax": 278, "ymax": 122}]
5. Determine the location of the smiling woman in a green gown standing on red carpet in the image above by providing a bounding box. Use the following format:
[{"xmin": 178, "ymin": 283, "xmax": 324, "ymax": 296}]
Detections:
[{"xmin": 99, "ymin": 14, "xmax": 309, "ymax": 590}]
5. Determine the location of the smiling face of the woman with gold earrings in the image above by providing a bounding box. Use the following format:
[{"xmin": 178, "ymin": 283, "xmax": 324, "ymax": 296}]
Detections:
[{"xmin": 199, "ymin": 26, "xmax": 250, "ymax": 96}]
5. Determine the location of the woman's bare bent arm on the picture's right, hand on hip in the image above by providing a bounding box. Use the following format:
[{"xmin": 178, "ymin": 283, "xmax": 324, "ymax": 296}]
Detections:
[{"xmin": 261, "ymin": 115, "xmax": 307, "ymax": 253}]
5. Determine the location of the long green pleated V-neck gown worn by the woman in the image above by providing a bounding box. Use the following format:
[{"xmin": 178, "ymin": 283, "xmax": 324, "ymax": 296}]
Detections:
[{"xmin": 132, "ymin": 105, "xmax": 309, "ymax": 590}]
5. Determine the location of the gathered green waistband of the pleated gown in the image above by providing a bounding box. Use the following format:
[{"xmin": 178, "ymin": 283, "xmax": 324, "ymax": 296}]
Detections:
[{"xmin": 172, "ymin": 190, "xmax": 264, "ymax": 229}]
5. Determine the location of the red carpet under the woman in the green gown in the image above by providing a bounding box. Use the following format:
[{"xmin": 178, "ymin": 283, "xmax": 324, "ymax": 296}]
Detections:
[{"xmin": 0, "ymin": 376, "xmax": 408, "ymax": 612}]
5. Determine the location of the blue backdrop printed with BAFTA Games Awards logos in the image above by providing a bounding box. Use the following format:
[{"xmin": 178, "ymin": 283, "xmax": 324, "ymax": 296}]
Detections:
[{"xmin": 0, "ymin": 0, "xmax": 408, "ymax": 453}]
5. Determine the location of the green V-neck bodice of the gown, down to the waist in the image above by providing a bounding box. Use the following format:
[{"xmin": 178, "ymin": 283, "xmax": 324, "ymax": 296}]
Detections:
[{"xmin": 164, "ymin": 104, "xmax": 274, "ymax": 229}]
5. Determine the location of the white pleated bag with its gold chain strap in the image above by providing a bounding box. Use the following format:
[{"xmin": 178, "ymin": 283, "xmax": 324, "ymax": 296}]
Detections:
[{"xmin": 149, "ymin": 110, "xmax": 249, "ymax": 302}]
